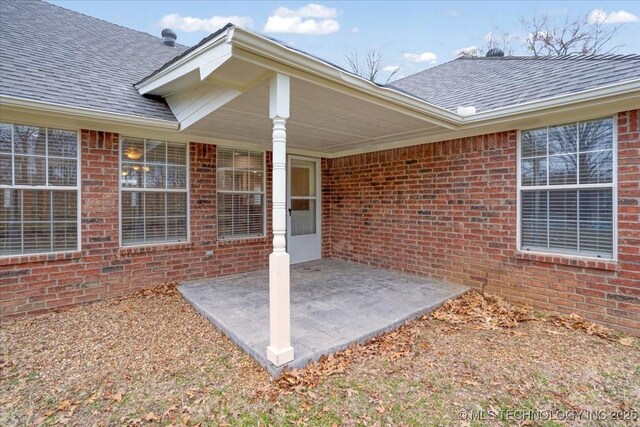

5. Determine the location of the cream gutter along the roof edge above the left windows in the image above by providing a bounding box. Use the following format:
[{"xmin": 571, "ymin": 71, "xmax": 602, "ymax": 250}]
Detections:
[{"xmin": 0, "ymin": 95, "xmax": 180, "ymax": 130}]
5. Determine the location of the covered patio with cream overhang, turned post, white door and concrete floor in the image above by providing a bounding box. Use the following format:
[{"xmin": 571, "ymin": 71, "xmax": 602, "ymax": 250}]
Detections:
[{"xmin": 135, "ymin": 25, "xmax": 470, "ymax": 373}]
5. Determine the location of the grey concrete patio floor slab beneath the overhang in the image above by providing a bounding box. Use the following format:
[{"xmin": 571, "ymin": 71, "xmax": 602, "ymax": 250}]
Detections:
[{"xmin": 179, "ymin": 259, "xmax": 467, "ymax": 377}]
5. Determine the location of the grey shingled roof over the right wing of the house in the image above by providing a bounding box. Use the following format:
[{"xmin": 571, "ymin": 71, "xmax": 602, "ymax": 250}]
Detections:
[{"xmin": 387, "ymin": 55, "xmax": 640, "ymax": 112}]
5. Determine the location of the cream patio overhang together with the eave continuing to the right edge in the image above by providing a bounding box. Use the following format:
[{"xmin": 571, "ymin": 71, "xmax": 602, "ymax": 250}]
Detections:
[{"xmin": 136, "ymin": 25, "xmax": 640, "ymax": 157}]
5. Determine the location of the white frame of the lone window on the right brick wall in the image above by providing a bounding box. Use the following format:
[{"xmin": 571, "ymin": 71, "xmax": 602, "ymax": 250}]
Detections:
[{"xmin": 516, "ymin": 116, "xmax": 618, "ymax": 261}]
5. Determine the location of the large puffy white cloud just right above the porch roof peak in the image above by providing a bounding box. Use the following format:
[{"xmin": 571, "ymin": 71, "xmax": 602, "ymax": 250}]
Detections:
[{"xmin": 263, "ymin": 3, "xmax": 340, "ymax": 35}]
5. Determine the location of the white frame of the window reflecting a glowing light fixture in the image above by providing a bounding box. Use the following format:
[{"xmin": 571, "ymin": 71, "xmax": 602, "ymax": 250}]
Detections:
[{"xmin": 118, "ymin": 135, "xmax": 191, "ymax": 249}]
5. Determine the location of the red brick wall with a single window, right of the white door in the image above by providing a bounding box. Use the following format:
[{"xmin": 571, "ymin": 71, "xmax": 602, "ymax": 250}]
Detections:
[{"xmin": 327, "ymin": 110, "xmax": 640, "ymax": 334}]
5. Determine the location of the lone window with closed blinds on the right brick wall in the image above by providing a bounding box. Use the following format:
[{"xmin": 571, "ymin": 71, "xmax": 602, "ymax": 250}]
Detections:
[{"xmin": 519, "ymin": 118, "xmax": 615, "ymax": 259}]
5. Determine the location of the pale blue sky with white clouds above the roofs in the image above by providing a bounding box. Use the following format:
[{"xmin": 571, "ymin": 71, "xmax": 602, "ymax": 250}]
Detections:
[{"xmin": 50, "ymin": 0, "xmax": 640, "ymax": 79}]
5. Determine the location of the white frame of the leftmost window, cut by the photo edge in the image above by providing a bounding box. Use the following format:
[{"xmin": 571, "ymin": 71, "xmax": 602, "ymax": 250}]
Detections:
[{"xmin": 0, "ymin": 121, "xmax": 82, "ymax": 258}]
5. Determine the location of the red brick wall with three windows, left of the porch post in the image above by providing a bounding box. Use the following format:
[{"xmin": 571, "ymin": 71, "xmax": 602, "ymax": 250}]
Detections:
[{"xmin": 0, "ymin": 130, "xmax": 271, "ymax": 318}]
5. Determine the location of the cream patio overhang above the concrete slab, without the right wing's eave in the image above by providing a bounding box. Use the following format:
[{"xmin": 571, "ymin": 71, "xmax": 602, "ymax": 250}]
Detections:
[{"xmin": 136, "ymin": 27, "xmax": 459, "ymax": 157}]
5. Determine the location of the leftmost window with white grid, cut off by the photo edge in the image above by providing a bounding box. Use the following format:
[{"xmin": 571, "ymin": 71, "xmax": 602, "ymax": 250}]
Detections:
[{"xmin": 0, "ymin": 123, "xmax": 79, "ymax": 256}]
